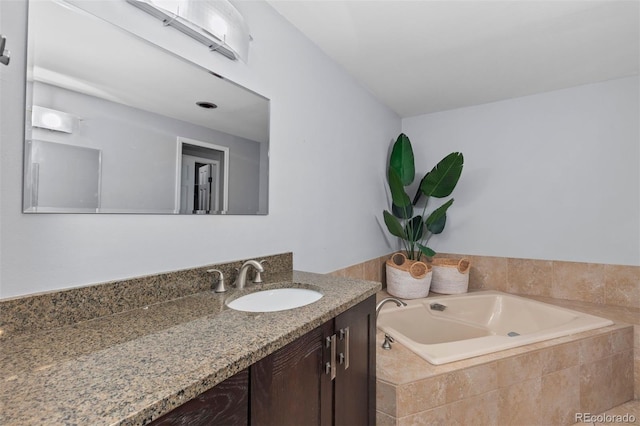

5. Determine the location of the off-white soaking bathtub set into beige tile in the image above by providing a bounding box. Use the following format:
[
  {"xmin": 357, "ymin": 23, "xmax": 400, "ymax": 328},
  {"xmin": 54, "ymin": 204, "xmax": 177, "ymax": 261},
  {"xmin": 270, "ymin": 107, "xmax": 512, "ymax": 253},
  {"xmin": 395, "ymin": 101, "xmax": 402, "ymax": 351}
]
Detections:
[{"xmin": 377, "ymin": 291, "xmax": 613, "ymax": 365}]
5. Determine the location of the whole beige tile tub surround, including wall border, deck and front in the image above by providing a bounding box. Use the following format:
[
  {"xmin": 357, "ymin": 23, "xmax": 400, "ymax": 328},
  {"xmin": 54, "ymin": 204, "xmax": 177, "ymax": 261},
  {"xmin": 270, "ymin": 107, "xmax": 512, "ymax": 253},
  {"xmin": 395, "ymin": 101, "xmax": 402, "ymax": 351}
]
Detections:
[{"xmin": 334, "ymin": 254, "xmax": 640, "ymax": 425}]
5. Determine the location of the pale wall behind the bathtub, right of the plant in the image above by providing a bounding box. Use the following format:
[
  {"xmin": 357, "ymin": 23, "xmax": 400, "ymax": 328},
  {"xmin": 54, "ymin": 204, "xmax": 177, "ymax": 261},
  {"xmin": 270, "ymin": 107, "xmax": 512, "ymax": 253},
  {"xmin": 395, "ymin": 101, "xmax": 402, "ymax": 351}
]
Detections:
[{"xmin": 402, "ymin": 76, "xmax": 640, "ymax": 265}]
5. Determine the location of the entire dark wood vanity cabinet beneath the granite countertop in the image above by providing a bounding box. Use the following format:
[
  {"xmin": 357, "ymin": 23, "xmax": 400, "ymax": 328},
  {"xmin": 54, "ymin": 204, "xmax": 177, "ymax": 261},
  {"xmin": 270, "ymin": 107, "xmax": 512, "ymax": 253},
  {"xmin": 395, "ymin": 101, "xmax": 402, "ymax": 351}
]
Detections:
[{"xmin": 152, "ymin": 296, "xmax": 376, "ymax": 426}]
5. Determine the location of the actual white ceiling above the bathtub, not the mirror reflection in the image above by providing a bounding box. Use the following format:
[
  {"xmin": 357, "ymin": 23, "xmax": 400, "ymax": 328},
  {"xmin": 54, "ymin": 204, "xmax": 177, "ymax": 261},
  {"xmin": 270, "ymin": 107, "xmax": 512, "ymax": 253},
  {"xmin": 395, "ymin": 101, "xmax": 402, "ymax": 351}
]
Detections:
[{"xmin": 268, "ymin": 0, "xmax": 640, "ymax": 117}]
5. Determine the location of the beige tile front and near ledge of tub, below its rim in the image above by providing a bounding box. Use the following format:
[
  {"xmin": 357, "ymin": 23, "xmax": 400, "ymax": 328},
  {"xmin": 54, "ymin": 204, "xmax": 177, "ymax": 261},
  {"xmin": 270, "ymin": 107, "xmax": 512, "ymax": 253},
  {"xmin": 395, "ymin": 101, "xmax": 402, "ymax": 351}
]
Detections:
[{"xmin": 377, "ymin": 325, "xmax": 633, "ymax": 426}]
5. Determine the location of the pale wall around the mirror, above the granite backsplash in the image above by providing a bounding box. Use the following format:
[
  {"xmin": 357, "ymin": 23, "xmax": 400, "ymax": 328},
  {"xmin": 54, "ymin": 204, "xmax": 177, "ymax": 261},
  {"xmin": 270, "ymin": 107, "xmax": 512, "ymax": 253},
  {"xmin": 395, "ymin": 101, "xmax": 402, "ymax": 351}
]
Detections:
[{"xmin": 0, "ymin": 1, "xmax": 400, "ymax": 298}]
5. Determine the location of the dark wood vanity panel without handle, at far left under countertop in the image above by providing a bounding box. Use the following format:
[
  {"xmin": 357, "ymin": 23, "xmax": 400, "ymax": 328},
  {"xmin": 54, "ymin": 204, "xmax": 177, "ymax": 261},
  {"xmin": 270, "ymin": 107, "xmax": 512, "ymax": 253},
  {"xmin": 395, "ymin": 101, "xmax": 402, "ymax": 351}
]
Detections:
[{"xmin": 151, "ymin": 370, "xmax": 249, "ymax": 426}]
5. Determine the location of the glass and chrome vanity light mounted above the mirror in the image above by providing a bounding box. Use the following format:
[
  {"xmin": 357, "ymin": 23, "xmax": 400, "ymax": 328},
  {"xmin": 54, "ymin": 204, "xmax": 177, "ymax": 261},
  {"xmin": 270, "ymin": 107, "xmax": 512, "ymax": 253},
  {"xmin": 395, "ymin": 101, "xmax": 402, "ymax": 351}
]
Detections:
[{"xmin": 127, "ymin": 0, "xmax": 251, "ymax": 62}]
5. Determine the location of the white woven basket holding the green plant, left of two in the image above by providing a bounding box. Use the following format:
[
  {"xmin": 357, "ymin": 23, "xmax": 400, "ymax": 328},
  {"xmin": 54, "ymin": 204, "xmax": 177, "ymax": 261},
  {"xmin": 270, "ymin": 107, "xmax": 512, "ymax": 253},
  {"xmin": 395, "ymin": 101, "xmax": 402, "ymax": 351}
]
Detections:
[{"xmin": 386, "ymin": 253, "xmax": 431, "ymax": 299}]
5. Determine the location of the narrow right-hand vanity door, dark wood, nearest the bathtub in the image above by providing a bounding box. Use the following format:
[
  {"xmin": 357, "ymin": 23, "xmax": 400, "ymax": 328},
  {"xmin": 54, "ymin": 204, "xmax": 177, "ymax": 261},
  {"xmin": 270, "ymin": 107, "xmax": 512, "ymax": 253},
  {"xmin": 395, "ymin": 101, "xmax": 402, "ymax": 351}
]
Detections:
[{"xmin": 334, "ymin": 296, "xmax": 376, "ymax": 425}]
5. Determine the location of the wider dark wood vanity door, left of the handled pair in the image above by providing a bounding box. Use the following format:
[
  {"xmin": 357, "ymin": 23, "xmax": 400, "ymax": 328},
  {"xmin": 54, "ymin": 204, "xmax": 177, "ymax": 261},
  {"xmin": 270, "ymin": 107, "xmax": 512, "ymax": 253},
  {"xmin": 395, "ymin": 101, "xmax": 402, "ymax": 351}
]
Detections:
[{"xmin": 250, "ymin": 321, "xmax": 333, "ymax": 426}]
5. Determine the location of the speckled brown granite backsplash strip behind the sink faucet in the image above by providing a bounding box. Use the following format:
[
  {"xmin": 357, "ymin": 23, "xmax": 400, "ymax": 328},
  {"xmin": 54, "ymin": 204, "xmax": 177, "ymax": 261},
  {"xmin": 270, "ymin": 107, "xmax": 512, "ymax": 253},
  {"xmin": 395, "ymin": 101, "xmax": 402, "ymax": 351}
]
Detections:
[{"xmin": 0, "ymin": 253, "xmax": 293, "ymax": 339}]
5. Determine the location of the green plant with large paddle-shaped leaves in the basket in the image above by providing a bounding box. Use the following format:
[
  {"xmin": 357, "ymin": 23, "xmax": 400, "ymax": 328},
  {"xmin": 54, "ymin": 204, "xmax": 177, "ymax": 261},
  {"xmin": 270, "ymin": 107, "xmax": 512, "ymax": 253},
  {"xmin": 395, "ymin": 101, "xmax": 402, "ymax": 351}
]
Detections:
[{"xmin": 383, "ymin": 133, "xmax": 464, "ymax": 260}]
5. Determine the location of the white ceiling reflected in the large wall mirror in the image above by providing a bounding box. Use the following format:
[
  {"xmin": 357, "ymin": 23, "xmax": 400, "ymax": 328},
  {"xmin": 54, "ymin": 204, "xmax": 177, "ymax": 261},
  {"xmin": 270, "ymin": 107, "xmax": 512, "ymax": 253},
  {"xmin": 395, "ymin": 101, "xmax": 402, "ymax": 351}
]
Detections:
[{"xmin": 28, "ymin": 0, "xmax": 269, "ymax": 142}]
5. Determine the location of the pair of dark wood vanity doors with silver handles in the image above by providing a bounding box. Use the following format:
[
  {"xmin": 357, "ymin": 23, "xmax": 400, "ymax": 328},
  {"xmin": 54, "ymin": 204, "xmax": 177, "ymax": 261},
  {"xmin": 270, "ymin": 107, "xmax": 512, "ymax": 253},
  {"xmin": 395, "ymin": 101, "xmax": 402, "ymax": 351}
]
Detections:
[{"xmin": 250, "ymin": 296, "xmax": 376, "ymax": 426}]
